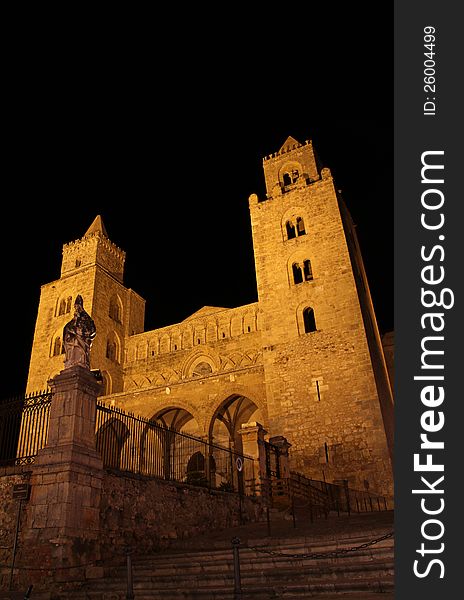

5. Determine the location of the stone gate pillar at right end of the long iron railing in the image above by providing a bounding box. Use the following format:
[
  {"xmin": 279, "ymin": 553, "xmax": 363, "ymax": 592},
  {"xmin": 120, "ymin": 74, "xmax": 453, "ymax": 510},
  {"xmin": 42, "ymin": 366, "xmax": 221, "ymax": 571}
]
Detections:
[{"xmin": 238, "ymin": 421, "xmax": 269, "ymax": 496}]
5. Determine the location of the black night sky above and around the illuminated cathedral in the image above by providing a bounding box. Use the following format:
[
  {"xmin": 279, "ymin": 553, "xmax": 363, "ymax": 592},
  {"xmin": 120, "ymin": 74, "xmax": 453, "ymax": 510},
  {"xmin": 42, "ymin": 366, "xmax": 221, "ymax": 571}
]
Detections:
[{"xmin": 0, "ymin": 5, "xmax": 393, "ymax": 397}]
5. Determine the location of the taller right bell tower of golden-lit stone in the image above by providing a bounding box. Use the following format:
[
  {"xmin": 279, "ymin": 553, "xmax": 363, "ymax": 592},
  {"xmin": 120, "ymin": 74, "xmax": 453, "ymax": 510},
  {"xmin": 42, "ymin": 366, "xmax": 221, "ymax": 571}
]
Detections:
[{"xmin": 249, "ymin": 137, "xmax": 393, "ymax": 493}]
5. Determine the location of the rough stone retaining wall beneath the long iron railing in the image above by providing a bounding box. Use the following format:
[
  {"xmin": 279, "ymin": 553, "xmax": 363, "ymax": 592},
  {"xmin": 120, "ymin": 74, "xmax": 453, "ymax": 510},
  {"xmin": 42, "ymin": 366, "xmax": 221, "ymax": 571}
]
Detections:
[{"xmin": 100, "ymin": 471, "xmax": 265, "ymax": 563}]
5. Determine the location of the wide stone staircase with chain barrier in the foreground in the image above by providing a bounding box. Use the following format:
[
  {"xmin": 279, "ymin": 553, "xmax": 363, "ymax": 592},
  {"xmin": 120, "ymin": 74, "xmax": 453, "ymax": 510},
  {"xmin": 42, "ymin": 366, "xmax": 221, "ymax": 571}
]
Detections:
[{"xmin": 66, "ymin": 512, "xmax": 394, "ymax": 600}]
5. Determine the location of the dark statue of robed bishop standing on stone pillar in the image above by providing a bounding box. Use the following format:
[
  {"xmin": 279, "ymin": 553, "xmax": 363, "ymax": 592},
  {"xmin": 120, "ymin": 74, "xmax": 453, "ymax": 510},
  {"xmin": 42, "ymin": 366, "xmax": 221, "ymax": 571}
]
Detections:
[{"xmin": 63, "ymin": 295, "xmax": 96, "ymax": 370}]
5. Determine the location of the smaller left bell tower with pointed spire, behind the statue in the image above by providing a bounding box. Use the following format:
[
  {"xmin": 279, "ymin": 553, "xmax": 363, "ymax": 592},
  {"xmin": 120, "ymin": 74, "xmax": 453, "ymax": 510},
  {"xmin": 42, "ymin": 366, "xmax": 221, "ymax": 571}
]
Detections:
[{"xmin": 26, "ymin": 216, "xmax": 145, "ymax": 394}]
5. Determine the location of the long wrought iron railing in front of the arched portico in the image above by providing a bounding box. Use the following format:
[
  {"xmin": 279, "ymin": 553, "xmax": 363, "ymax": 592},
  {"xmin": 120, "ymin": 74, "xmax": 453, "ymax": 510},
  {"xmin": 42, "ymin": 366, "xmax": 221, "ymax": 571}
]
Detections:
[{"xmin": 96, "ymin": 401, "xmax": 253, "ymax": 494}]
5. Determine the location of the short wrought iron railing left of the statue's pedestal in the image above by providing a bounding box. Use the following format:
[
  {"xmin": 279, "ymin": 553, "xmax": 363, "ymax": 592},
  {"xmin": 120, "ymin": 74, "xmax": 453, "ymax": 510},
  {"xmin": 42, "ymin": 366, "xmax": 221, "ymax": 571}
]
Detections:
[{"xmin": 0, "ymin": 391, "xmax": 52, "ymax": 466}]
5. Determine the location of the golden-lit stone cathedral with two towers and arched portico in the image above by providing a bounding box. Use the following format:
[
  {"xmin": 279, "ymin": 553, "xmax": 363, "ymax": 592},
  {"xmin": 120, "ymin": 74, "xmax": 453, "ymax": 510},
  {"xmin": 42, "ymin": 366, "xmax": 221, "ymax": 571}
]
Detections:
[{"xmin": 27, "ymin": 137, "xmax": 393, "ymax": 494}]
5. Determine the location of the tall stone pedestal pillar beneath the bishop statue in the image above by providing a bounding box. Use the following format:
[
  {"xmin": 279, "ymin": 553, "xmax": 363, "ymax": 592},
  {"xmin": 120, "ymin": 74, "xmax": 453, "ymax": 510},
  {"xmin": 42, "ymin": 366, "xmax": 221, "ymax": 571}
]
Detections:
[{"xmin": 18, "ymin": 365, "xmax": 103, "ymax": 583}]
